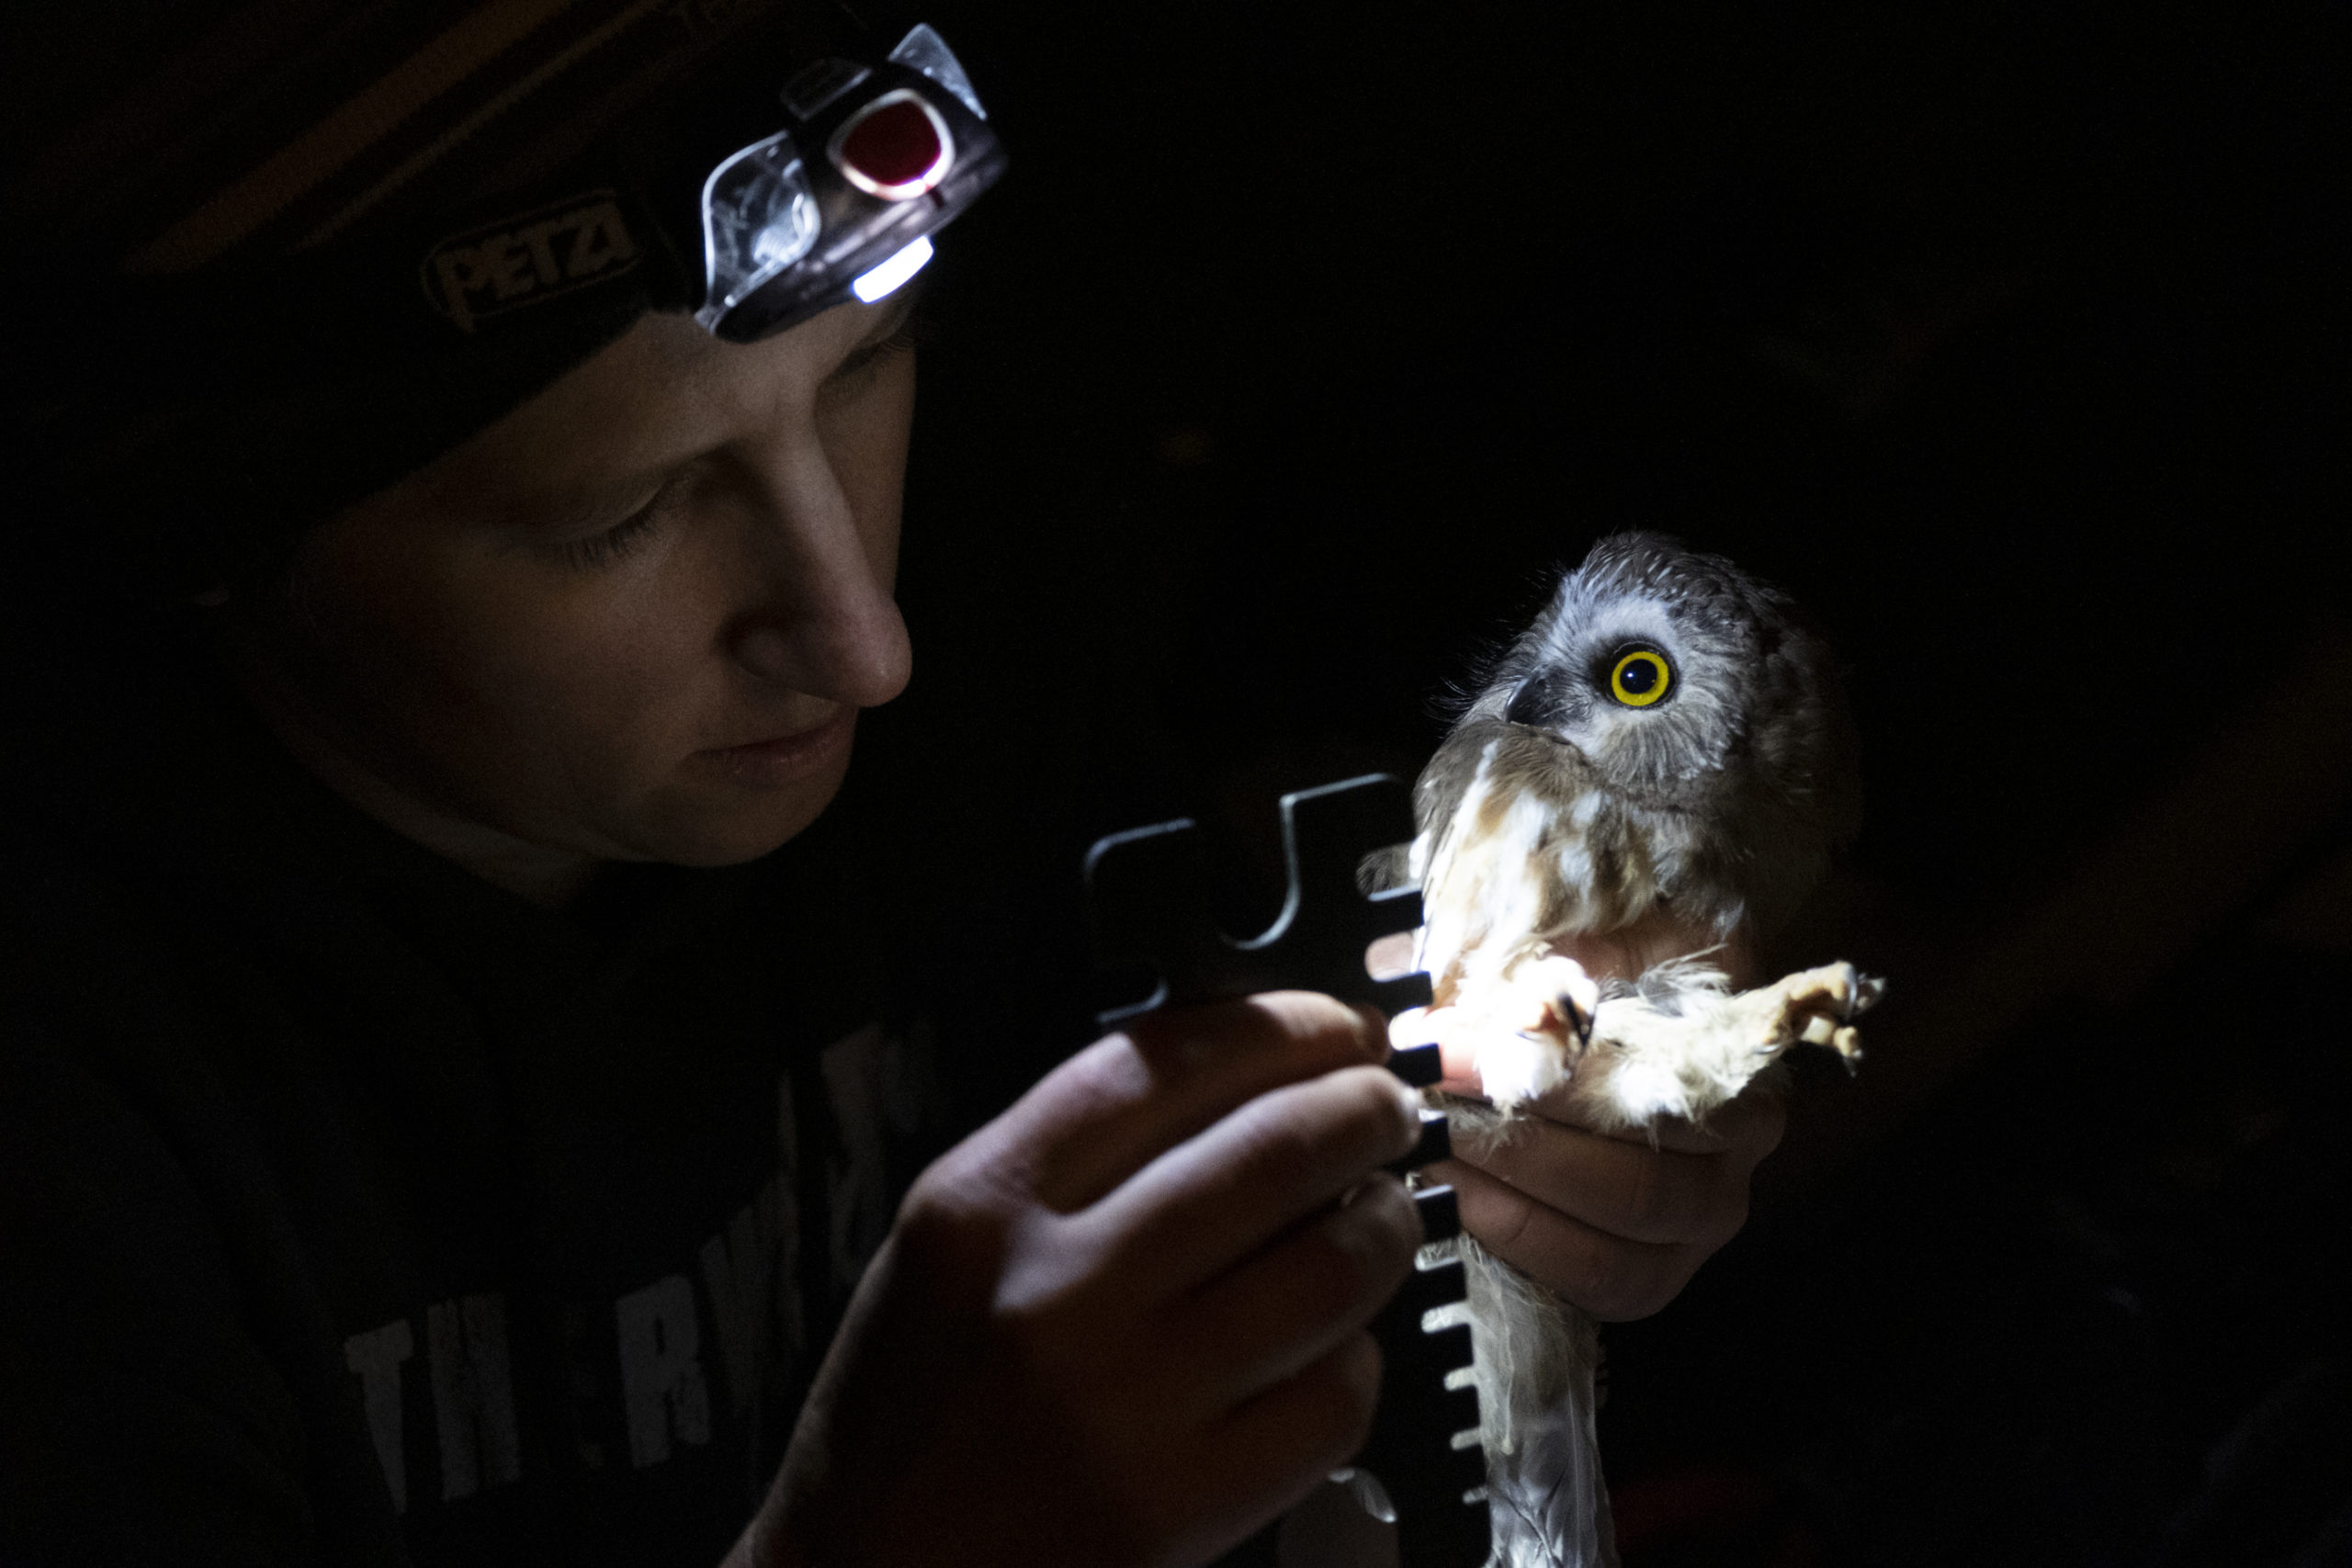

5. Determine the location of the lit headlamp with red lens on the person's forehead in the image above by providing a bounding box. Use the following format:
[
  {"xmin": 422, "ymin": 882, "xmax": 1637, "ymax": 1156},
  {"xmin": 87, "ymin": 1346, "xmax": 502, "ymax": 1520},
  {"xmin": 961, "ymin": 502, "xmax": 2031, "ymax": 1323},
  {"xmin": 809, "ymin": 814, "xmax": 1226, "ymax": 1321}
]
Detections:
[{"xmin": 694, "ymin": 26, "xmax": 1004, "ymax": 344}]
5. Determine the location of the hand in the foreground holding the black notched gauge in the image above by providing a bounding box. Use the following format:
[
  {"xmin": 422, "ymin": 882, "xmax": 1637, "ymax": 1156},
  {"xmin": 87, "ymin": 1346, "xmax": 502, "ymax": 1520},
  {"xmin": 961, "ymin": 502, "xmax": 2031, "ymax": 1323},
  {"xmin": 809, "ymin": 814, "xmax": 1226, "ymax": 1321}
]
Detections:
[{"xmin": 729, "ymin": 992, "xmax": 1420, "ymax": 1568}]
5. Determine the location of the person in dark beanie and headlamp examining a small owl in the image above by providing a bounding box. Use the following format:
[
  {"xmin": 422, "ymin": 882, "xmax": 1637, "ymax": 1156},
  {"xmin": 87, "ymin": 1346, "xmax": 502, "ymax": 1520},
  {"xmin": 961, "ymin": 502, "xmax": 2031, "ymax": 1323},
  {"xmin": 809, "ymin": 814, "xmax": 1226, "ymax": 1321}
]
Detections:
[{"xmin": 0, "ymin": 0, "xmax": 1778, "ymax": 1568}]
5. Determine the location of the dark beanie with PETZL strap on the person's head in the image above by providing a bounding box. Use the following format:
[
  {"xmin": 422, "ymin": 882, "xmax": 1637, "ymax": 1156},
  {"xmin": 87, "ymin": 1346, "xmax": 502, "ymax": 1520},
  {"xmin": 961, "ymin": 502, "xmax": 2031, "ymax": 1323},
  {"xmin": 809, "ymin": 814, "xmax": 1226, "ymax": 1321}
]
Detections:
[{"xmin": 5, "ymin": 0, "xmax": 864, "ymax": 588}]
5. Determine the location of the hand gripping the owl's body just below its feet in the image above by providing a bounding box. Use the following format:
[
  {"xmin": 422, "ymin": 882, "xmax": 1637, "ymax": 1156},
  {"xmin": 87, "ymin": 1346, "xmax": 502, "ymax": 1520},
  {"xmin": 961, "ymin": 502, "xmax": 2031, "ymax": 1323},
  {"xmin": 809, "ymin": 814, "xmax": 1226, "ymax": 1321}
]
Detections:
[{"xmin": 1430, "ymin": 1086, "xmax": 1788, "ymax": 1321}]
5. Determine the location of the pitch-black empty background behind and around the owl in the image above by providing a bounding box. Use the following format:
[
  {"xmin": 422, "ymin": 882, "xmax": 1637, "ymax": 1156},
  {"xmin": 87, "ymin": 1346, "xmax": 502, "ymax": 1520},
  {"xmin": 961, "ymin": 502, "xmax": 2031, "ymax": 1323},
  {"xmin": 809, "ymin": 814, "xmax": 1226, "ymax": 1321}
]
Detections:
[{"xmin": 868, "ymin": 0, "xmax": 2352, "ymax": 1568}]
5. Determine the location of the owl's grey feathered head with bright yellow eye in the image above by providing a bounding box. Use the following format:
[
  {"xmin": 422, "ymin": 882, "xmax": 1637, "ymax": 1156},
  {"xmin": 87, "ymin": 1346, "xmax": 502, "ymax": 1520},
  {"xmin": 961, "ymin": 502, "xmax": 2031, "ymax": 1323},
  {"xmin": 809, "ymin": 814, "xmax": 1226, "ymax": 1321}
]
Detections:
[{"xmin": 1423, "ymin": 534, "xmax": 1860, "ymax": 929}]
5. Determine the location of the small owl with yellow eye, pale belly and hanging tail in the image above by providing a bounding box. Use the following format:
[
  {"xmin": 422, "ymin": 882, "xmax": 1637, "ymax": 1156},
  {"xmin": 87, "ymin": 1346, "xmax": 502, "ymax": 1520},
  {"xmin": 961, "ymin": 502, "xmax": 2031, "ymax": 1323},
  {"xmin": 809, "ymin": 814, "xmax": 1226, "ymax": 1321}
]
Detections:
[{"xmin": 1369, "ymin": 534, "xmax": 1879, "ymax": 1568}]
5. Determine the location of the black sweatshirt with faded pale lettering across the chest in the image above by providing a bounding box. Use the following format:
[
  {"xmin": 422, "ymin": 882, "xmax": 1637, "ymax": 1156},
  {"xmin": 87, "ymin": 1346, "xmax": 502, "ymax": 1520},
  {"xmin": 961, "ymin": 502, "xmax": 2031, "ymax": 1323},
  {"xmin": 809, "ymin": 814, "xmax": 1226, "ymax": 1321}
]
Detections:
[{"xmin": 0, "ymin": 682, "xmax": 941, "ymax": 1568}]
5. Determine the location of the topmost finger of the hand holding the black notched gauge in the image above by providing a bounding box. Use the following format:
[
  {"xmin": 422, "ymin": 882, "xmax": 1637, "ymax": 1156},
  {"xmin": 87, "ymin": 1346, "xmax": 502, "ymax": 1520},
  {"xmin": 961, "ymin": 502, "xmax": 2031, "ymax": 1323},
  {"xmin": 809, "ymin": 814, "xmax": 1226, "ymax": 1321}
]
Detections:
[{"xmin": 988, "ymin": 992, "xmax": 1387, "ymax": 1213}]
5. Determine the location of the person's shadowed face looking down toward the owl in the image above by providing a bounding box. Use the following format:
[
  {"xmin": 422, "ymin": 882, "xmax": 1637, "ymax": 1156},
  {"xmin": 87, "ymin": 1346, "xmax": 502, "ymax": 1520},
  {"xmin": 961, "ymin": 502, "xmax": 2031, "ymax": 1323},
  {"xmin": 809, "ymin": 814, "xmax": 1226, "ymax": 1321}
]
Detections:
[{"xmin": 238, "ymin": 296, "xmax": 915, "ymax": 865}]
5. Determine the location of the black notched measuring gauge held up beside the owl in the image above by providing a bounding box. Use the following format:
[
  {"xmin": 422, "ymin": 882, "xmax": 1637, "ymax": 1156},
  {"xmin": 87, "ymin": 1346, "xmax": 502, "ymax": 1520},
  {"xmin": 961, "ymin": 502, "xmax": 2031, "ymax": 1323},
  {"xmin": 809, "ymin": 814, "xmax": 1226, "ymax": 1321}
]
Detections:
[{"xmin": 1087, "ymin": 773, "xmax": 1488, "ymax": 1568}]
